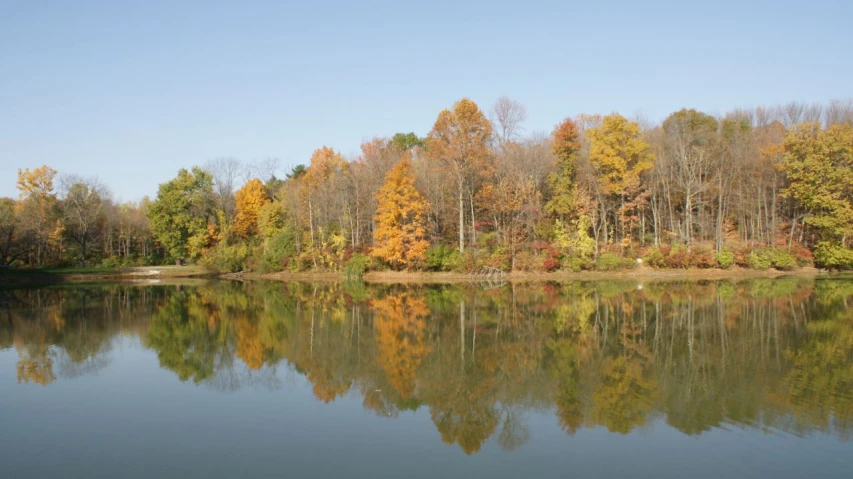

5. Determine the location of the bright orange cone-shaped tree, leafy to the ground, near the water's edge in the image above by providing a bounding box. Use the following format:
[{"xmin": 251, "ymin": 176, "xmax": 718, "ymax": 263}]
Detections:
[{"xmin": 370, "ymin": 155, "xmax": 429, "ymax": 268}]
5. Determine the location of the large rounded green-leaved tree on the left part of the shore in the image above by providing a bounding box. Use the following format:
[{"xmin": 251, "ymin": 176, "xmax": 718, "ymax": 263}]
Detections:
[{"xmin": 148, "ymin": 167, "xmax": 213, "ymax": 259}]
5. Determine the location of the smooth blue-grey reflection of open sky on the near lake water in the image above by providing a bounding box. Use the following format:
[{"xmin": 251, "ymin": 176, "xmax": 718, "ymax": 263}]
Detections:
[{"xmin": 0, "ymin": 282, "xmax": 853, "ymax": 478}]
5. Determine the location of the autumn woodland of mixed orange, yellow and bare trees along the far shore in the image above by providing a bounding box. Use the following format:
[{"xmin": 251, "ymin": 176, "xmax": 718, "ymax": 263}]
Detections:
[{"xmin": 5, "ymin": 97, "xmax": 853, "ymax": 275}]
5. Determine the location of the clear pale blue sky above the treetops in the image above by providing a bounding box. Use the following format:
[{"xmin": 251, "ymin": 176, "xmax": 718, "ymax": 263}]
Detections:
[{"xmin": 0, "ymin": 0, "xmax": 853, "ymax": 201}]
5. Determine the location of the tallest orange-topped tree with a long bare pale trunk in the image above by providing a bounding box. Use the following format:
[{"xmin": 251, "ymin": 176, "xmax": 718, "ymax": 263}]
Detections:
[{"xmin": 426, "ymin": 98, "xmax": 492, "ymax": 252}]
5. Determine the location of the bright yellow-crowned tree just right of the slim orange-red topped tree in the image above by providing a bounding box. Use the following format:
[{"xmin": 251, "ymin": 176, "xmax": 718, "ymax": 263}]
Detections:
[{"xmin": 588, "ymin": 113, "xmax": 655, "ymax": 246}]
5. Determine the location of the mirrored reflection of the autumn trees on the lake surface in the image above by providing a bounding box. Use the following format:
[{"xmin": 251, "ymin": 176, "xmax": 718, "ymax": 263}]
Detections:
[{"xmin": 0, "ymin": 278, "xmax": 853, "ymax": 454}]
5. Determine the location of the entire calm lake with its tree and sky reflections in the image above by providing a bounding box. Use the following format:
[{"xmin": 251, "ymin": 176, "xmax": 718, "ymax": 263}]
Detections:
[{"xmin": 0, "ymin": 279, "xmax": 853, "ymax": 479}]
